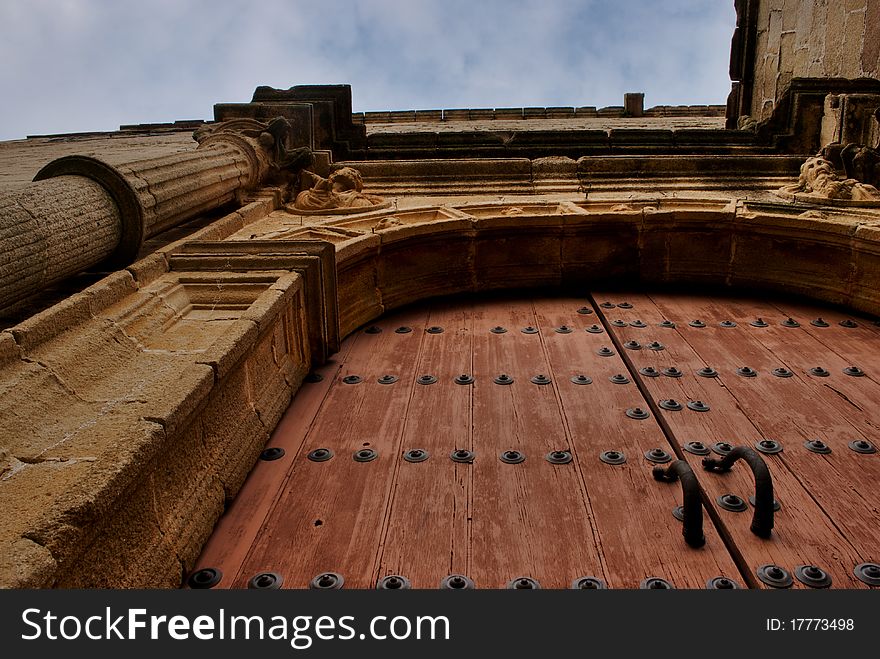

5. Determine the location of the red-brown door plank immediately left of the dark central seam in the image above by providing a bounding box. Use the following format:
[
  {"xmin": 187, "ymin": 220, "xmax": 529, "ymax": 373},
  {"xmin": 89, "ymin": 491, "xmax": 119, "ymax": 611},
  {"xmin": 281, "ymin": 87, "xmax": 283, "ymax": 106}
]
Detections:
[{"xmin": 534, "ymin": 298, "xmax": 743, "ymax": 588}]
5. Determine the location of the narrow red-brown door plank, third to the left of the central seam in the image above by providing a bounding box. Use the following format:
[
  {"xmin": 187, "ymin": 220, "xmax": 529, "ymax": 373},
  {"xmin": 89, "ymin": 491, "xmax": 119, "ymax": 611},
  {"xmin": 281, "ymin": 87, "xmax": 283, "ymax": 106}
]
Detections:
[{"xmin": 377, "ymin": 301, "xmax": 473, "ymax": 588}]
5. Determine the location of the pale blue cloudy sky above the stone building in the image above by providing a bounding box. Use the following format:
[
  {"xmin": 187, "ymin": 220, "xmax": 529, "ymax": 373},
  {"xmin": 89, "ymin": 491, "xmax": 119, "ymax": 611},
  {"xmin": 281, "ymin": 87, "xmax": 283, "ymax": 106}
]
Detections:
[{"xmin": 0, "ymin": 0, "xmax": 735, "ymax": 140}]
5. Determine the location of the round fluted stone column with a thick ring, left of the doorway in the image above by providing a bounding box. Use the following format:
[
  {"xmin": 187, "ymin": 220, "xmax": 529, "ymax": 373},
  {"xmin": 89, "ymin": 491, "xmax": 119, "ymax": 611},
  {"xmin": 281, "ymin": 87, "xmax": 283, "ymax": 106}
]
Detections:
[{"xmin": 0, "ymin": 120, "xmax": 284, "ymax": 308}]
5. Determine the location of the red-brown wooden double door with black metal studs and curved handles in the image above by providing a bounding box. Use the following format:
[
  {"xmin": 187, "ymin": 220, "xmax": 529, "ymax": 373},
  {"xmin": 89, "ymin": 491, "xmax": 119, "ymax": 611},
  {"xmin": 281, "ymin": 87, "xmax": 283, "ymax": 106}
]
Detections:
[{"xmin": 197, "ymin": 292, "xmax": 880, "ymax": 588}]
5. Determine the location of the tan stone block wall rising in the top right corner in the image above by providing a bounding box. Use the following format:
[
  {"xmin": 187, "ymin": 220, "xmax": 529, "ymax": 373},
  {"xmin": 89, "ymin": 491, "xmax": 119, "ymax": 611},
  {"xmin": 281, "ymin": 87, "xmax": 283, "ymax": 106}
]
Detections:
[{"xmin": 746, "ymin": 0, "xmax": 880, "ymax": 120}]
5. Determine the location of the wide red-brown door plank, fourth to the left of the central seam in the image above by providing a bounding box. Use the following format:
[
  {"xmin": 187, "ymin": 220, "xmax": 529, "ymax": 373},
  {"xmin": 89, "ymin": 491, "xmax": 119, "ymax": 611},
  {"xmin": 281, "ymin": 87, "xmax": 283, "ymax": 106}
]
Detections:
[{"xmin": 233, "ymin": 309, "xmax": 427, "ymax": 588}]
